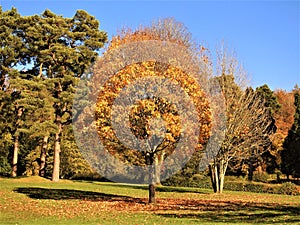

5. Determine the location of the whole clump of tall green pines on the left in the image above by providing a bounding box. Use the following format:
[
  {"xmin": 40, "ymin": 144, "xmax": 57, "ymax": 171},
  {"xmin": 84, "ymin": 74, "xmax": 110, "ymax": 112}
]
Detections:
[{"xmin": 0, "ymin": 8, "xmax": 107, "ymax": 181}]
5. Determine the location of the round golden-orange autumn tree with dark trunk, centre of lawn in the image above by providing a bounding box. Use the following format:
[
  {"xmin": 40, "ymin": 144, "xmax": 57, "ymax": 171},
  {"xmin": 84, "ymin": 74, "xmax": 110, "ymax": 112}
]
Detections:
[{"xmin": 74, "ymin": 19, "xmax": 211, "ymax": 203}]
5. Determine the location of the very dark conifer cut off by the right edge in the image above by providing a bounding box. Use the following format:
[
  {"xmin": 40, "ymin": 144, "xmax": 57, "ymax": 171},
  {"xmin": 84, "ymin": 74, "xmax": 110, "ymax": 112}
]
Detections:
[{"xmin": 281, "ymin": 89, "xmax": 300, "ymax": 179}]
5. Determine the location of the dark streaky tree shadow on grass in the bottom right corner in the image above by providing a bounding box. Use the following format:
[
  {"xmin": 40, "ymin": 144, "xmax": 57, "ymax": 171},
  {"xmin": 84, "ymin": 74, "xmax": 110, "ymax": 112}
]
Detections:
[{"xmin": 157, "ymin": 201, "xmax": 300, "ymax": 224}]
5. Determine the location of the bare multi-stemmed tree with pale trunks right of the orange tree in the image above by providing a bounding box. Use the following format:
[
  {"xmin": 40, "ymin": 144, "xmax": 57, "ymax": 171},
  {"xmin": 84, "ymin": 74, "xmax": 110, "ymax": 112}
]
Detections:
[{"xmin": 209, "ymin": 44, "xmax": 273, "ymax": 193}]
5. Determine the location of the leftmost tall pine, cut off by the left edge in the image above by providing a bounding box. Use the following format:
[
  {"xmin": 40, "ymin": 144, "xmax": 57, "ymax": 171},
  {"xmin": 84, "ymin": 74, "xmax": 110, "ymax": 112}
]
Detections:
[{"xmin": 0, "ymin": 7, "xmax": 31, "ymax": 177}]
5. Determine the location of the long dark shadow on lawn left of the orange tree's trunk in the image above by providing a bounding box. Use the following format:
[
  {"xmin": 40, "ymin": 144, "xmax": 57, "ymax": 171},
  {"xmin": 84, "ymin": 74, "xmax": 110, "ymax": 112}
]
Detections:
[{"xmin": 14, "ymin": 187, "xmax": 144, "ymax": 203}]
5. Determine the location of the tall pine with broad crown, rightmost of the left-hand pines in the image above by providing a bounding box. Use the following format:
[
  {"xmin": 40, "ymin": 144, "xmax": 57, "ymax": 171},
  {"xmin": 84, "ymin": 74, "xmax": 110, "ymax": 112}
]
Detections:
[{"xmin": 24, "ymin": 10, "xmax": 107, "ymax": 181}]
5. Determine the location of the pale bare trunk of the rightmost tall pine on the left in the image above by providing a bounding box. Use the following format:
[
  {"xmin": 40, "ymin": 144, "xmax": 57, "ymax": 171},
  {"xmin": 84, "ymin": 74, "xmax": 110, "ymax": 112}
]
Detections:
[{"xmin": 52, "ymin": 115, "xmax": 62, "ymax": 182}]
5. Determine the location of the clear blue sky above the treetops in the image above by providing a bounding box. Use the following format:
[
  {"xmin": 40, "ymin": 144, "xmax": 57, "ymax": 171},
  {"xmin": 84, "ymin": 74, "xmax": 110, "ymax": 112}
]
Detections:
[{"xmin": 0, "ymin": 0, "xmax": 300, "ymax": 90}]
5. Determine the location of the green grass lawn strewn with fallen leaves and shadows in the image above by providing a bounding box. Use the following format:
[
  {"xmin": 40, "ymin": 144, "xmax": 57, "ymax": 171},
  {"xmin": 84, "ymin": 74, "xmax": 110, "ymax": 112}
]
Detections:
[{"xmin": 0, "ymin": 177, "xmax": 300, "ymax": 225}]
